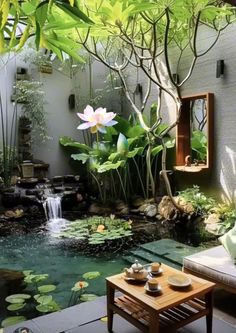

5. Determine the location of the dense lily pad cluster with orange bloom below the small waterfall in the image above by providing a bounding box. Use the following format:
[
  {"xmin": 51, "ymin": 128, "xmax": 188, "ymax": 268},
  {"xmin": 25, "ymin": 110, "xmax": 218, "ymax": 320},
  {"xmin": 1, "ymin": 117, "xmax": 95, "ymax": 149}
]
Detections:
[{"xmin": 52, "ymin": 216, "xmax": 132, "ymax": 245}]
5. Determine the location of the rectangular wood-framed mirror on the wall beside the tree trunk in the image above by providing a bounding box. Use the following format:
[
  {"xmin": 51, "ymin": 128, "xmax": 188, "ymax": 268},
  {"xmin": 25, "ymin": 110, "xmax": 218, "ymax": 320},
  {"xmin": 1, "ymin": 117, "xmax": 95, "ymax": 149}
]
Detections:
[{"xmin": 175, "ymin": 93, "xmax": 214, "ymax": 172}]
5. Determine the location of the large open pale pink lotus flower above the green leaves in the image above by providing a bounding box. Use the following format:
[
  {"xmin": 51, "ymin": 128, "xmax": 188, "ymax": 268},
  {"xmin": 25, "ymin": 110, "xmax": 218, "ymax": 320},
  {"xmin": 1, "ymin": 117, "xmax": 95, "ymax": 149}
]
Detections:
[{"xmin": 77, "ymin": 105, "xmax": 117, "ymax": 133}]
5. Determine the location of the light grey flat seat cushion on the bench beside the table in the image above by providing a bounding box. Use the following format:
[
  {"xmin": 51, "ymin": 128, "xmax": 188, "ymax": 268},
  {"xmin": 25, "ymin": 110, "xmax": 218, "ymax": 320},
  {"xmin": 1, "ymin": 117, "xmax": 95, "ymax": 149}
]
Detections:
[{"xmin": 183, "ymin": 245, "xmax": 236, "ymax": 288}]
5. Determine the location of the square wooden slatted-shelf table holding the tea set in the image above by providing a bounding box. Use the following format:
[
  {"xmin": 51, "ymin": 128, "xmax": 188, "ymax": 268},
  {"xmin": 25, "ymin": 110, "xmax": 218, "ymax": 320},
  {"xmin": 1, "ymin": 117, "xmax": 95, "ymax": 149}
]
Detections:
[{"xmin": 106, "ymin": 264, "xmax": 215, "ymax": 333}]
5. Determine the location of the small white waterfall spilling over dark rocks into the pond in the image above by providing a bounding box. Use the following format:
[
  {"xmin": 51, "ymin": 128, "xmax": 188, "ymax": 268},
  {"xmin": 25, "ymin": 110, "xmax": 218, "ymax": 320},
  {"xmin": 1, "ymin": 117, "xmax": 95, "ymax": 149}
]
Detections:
[{"xmin": 43, "ymin": 196, "xmax": 67, "ymax": 234}]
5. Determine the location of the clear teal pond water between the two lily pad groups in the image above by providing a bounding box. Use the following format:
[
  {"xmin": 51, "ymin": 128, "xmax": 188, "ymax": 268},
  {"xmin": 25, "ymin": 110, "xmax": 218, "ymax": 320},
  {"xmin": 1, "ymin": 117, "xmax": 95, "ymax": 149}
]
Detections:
[{"xmin": 0, "ymin": 233, "xmax": 127, "ymax": 319}]
